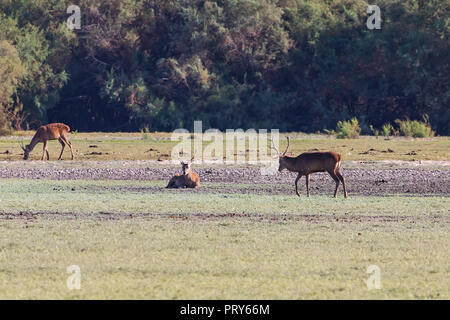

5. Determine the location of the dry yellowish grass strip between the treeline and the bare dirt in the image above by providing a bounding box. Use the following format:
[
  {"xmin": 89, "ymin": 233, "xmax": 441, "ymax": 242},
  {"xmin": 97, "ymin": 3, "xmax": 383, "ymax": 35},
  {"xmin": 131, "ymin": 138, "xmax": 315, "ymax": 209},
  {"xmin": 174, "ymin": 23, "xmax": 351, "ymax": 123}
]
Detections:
[{"xmin": 0, "ymin": 131, "xmax": 450, "ymax": 161}]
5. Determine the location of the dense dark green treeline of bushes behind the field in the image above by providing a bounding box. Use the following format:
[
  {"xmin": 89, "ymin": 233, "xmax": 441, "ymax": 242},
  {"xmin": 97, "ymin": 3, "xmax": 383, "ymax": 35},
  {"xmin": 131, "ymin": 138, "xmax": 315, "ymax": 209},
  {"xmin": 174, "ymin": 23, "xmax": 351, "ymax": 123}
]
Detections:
[{"xmin": 0, "ymin": 0, "xmax": 450, "ymax": 135}]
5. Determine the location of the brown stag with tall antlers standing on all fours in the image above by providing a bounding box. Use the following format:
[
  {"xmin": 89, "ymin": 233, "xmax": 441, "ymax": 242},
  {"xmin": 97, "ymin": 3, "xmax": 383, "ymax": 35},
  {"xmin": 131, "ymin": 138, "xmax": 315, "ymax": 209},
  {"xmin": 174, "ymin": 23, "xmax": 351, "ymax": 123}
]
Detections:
[{"xmin": 272, "ymin": 137, "xmax": 347, "ymax": 198}]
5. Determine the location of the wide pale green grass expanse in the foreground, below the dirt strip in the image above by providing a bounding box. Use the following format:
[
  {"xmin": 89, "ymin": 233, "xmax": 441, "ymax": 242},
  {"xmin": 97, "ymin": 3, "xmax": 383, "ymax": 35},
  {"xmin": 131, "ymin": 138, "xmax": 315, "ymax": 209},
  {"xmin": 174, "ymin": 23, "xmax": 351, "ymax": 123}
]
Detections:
[{"xmin": 0, "ymin": 179, "xmax": 450, "ymax": 299}]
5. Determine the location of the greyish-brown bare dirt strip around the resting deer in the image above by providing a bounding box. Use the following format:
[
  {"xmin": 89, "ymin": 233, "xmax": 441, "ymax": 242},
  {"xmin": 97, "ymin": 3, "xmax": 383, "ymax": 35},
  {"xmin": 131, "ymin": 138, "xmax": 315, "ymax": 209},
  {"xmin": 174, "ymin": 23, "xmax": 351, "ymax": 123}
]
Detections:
[{"xmin": 0, "ymin": 161, "xmax": 450, "ymax": 196}]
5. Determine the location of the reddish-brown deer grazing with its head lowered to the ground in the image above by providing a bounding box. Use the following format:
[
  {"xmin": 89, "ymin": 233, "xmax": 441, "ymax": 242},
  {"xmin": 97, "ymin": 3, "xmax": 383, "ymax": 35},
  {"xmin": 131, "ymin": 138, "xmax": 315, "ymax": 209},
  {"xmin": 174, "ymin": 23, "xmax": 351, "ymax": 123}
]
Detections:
[{"xmin": 21, "ymin": 123, "xmax": 73, "ymax": 160}]
